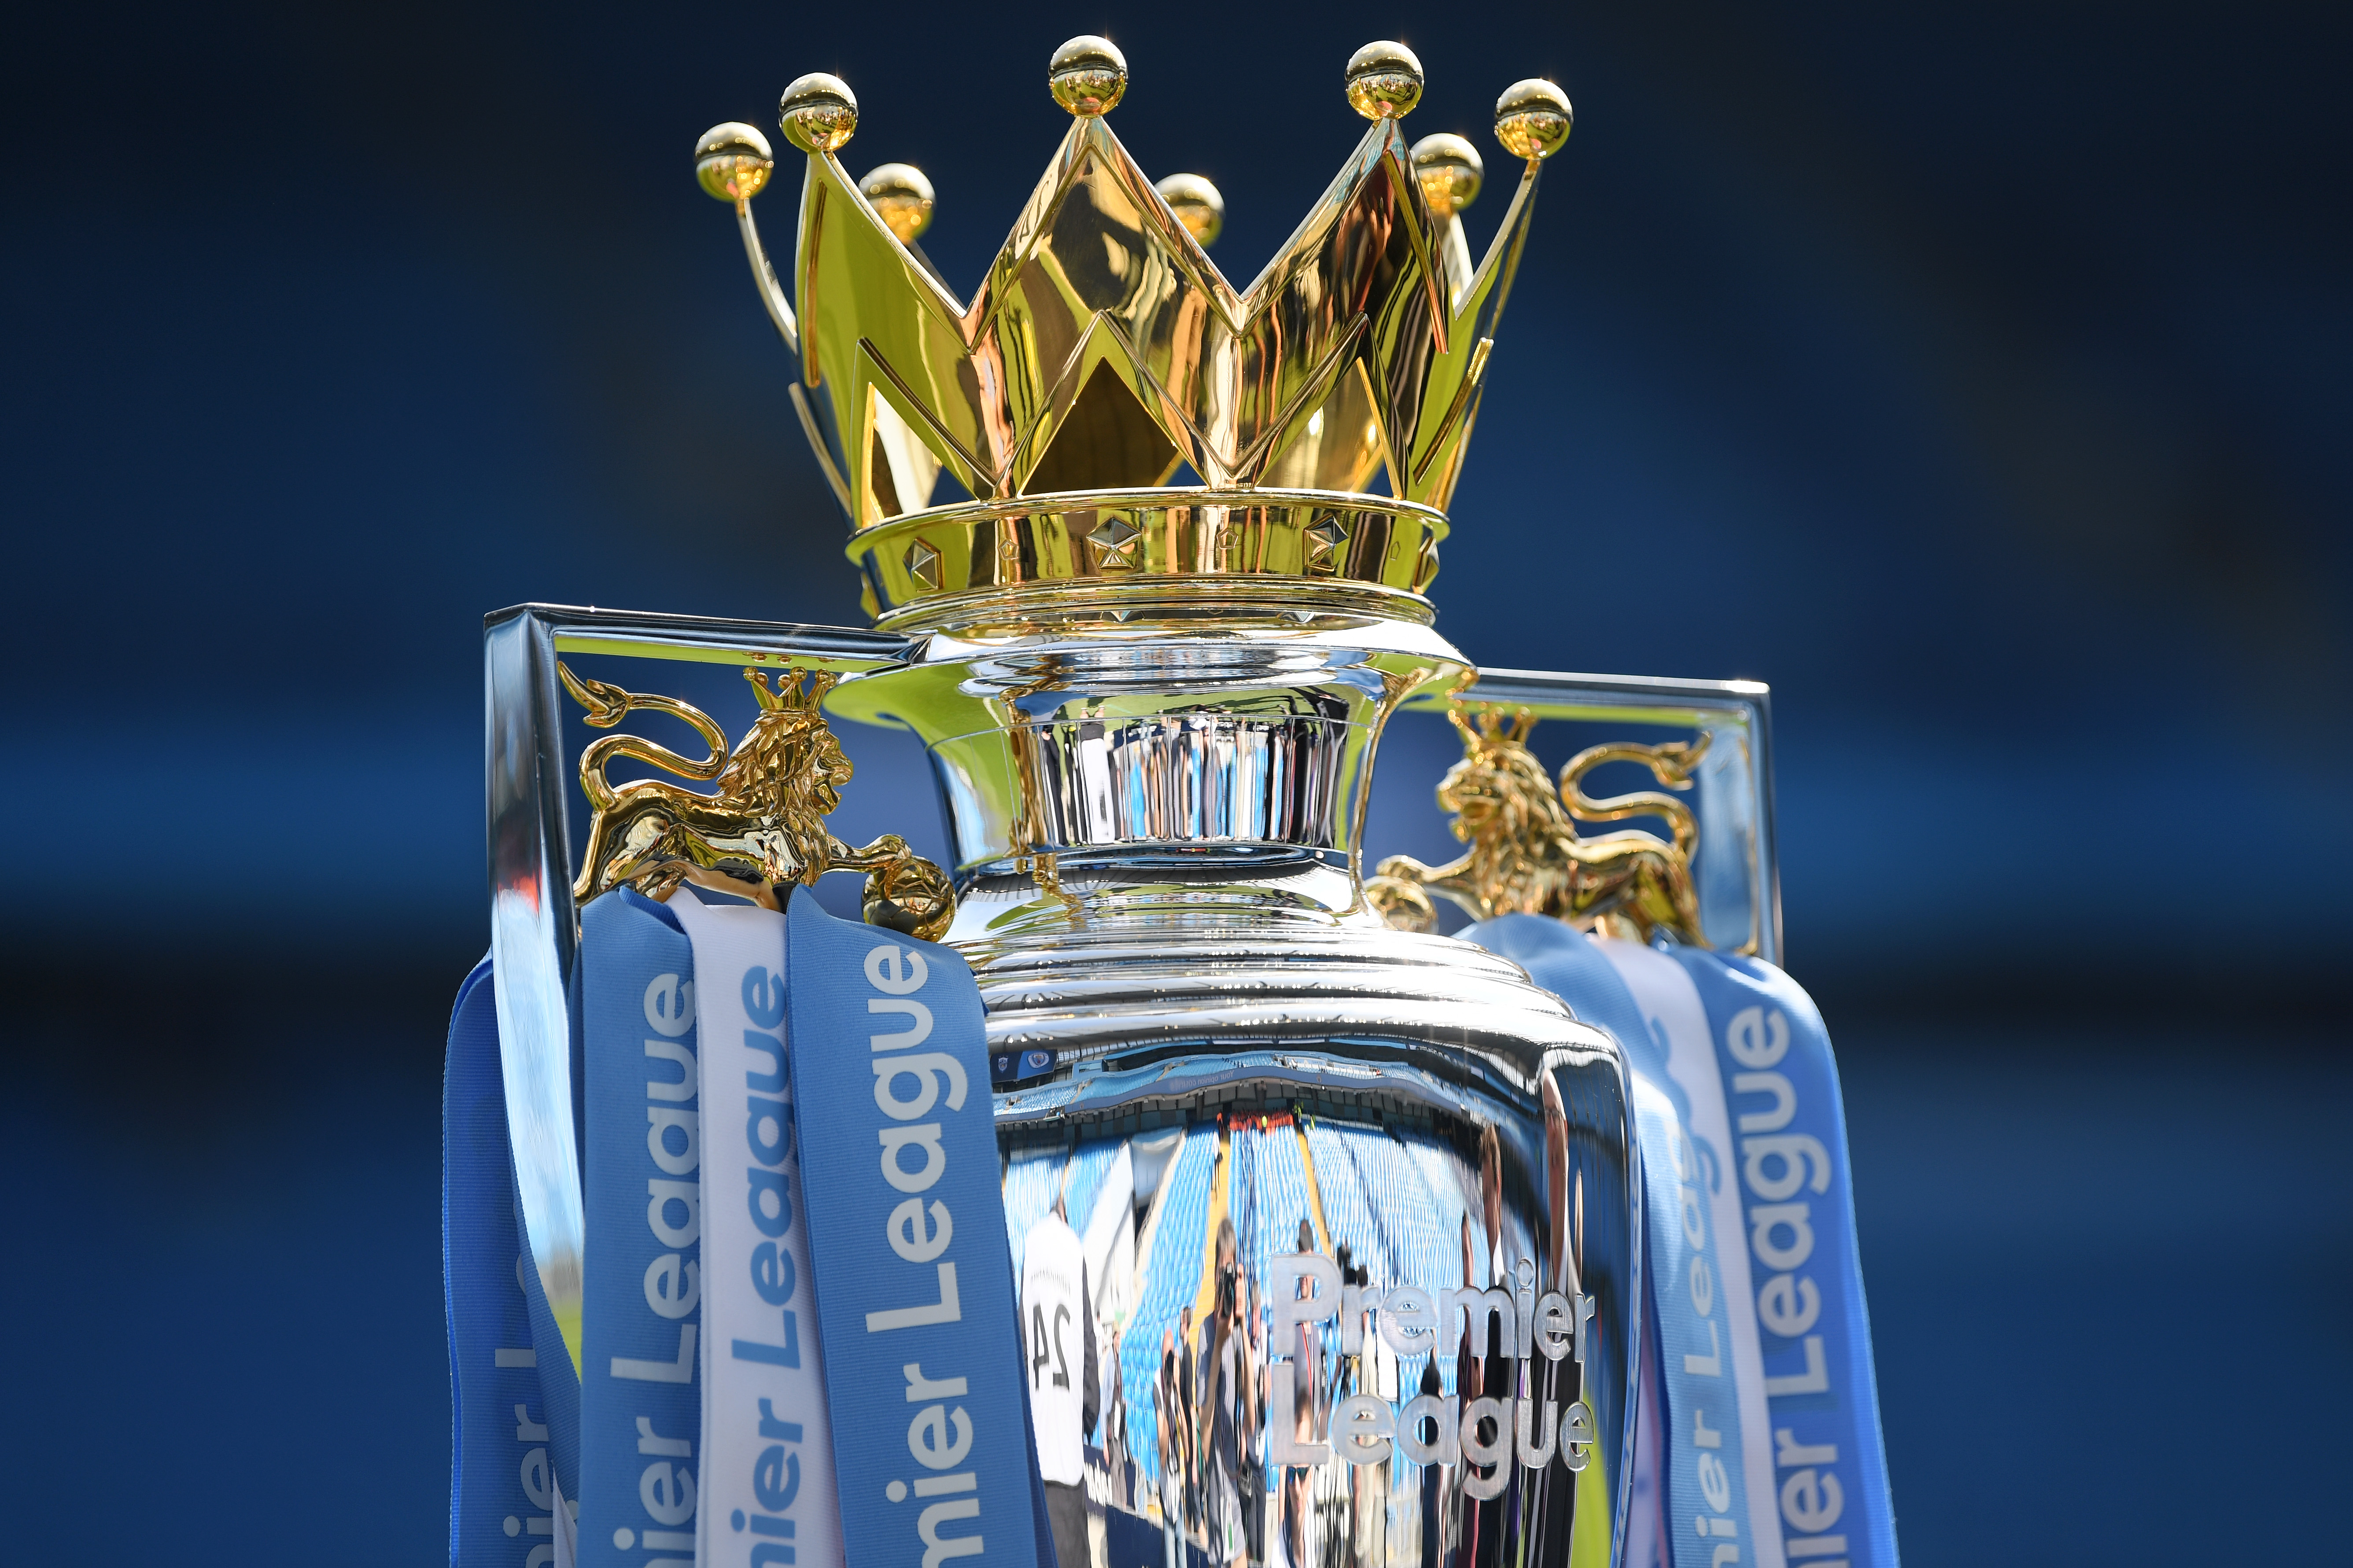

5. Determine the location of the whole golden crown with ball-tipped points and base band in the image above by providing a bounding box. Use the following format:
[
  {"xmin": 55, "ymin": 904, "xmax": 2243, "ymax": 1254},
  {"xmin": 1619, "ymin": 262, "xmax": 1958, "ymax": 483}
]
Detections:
[{"xmin": 697, "ymin": 37, "xmax": 1569, "ymax": 621}]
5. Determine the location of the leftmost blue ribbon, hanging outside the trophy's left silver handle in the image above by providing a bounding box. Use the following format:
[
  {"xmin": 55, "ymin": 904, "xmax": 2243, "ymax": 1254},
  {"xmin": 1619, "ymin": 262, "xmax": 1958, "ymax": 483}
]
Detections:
[{"xmin": 443, "ymin": 959, "xmax": 572, "ymax": 1568}]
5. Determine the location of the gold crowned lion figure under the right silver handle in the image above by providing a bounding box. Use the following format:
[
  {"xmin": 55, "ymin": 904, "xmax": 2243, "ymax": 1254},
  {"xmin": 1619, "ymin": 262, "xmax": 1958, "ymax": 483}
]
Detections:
[{"xmin": 1365, "ymin": 705, "xmax": 1708, "ymax": 947}]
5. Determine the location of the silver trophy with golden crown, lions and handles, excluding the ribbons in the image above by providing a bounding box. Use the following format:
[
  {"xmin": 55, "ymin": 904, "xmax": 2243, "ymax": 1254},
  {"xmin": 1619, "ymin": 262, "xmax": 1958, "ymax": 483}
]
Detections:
[{"xmin": 485, "ymin": 37, "xmax": 1779, "ymax": 1568}]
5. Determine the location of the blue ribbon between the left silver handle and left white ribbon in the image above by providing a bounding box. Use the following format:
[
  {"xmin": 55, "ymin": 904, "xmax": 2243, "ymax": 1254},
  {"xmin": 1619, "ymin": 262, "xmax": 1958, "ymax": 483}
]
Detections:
[{"xmin": 579, "ymin": 889, "xmax": 704, "ymax": 1568}]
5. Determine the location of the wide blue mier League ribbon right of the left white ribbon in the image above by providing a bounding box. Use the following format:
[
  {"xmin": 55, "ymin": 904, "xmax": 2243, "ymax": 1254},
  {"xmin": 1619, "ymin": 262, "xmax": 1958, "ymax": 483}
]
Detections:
[{"xmin": 786, "ymin": 896, "xmax": 1040, "ymax": 1568}]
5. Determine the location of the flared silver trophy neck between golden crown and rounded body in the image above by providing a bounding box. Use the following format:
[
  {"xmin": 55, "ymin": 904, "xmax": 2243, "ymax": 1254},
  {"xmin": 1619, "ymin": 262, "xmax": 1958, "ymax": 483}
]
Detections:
[{"xmin": 828, "ymin": 583, "xmax": 1468, "ymax": 945}]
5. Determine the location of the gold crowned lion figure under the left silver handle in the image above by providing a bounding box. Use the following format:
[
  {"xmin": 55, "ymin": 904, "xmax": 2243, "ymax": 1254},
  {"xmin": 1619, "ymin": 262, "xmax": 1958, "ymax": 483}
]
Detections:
[{"xmin": 555, "ymin": 663, "xmax": 955, "ymax": 940}]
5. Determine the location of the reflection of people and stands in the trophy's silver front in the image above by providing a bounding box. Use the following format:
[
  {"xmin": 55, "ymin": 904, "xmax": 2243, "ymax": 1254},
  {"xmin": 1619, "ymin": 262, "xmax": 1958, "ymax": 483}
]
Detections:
[{"xmin": 1005, "ymin": 1096, "xmax": 1581, "ymax": 1568}]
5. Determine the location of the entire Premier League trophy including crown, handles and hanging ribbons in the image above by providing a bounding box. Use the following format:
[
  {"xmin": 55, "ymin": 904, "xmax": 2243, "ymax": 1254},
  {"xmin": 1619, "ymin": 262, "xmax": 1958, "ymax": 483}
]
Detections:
[{"xmin": 445, "ymin": 37, "xmax": 1894, "ymax": 1568}]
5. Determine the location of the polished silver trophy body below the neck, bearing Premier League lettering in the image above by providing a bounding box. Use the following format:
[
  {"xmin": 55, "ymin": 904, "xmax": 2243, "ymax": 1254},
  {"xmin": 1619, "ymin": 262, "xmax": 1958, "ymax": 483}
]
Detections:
[{"xmin": 988, "ymin": 928, "xmax": 1642, "ymax": 1568}]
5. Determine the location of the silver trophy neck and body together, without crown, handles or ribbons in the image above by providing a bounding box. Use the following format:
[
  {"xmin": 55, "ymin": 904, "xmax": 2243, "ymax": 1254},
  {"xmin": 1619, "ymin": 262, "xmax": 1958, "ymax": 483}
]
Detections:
[{"xmin": 833, "ymin": 576, "xmax": 1640, "ymax": 1568}]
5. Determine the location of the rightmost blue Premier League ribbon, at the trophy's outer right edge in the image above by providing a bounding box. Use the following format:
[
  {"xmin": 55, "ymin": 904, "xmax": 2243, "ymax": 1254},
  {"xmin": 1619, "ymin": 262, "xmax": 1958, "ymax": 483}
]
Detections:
[{"xmin": 1673, "ymin": 947, "xmax": 1896, "ymax": 1568}]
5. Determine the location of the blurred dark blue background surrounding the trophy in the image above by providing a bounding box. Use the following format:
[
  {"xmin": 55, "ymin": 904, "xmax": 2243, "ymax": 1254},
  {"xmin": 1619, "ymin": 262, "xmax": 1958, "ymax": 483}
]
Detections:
[{"xmin": 0, "ymin": 0, "xmax": 2353, "ymax": 1568}]
